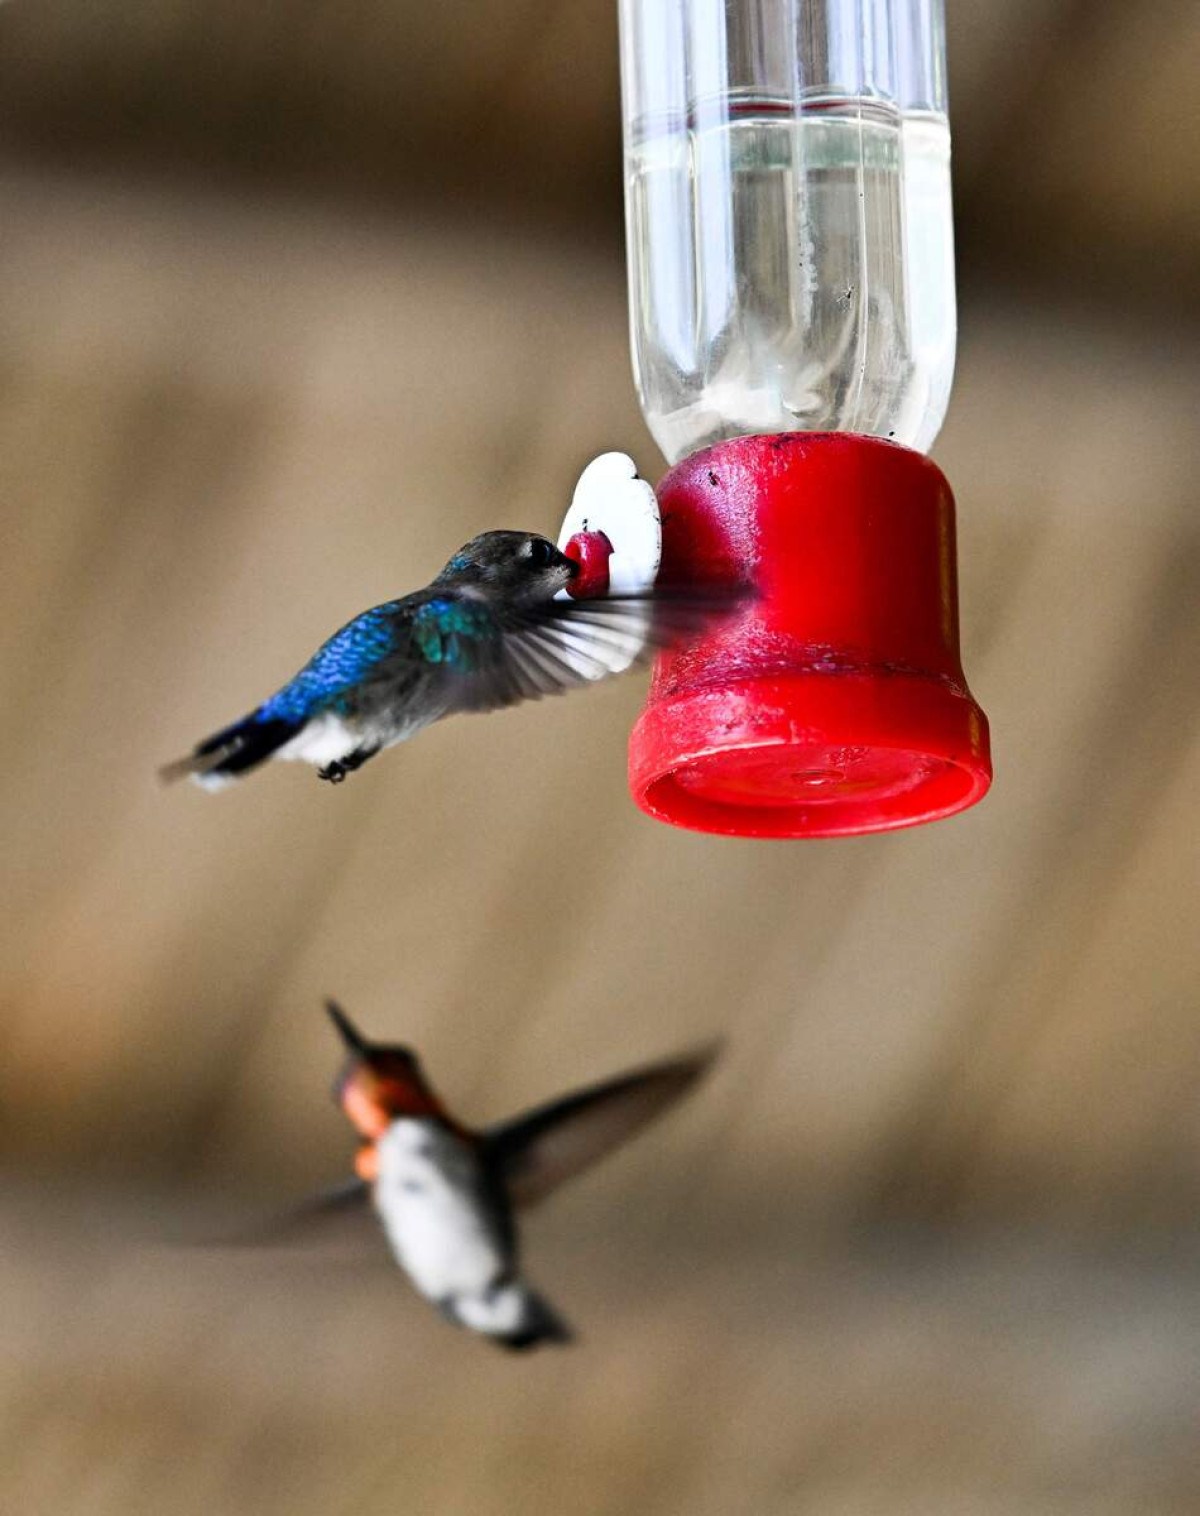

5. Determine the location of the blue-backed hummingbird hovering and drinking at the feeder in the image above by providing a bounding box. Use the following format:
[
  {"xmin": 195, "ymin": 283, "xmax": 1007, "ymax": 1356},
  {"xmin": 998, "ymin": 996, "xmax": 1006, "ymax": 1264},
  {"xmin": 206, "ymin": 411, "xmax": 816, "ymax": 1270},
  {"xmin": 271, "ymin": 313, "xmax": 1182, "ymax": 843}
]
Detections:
[{"xmin": 161, "ymin": 531, "xmax": 736, "ymax": 790}]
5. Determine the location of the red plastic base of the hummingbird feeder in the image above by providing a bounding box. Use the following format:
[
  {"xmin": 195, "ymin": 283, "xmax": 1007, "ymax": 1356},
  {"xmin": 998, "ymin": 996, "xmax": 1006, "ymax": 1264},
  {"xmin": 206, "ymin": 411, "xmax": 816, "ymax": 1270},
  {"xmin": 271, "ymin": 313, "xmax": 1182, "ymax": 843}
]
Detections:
[{"xmin": 629, "ymin": 432, "xmax": 991, "ymax": 837}]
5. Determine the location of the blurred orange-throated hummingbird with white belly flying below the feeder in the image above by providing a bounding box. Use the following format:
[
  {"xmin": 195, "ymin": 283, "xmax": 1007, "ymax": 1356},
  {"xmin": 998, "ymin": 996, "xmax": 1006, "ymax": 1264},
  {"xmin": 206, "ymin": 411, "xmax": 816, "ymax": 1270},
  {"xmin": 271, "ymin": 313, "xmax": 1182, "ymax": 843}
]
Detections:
[{"xmin": 302, "ymin": 1001, "xmax": 717, "ymax": 1349}]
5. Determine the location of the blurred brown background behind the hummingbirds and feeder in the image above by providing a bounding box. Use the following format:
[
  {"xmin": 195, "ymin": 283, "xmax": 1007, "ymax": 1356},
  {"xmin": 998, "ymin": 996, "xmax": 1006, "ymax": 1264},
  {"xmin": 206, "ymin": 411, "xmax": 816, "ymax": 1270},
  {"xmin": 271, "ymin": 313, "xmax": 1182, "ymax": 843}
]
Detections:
[{"xmin": 0, "ymin": 0, "xmax": 1200, "ymax": 1516}]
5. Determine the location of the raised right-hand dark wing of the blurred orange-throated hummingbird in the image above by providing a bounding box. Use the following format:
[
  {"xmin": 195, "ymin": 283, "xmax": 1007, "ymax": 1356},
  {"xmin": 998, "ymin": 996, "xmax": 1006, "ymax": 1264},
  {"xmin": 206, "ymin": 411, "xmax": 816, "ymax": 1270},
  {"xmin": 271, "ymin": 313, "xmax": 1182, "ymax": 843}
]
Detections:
[{"xmin": 480, "ymin": 1043, "xmax": 720, "ymax": 1205}]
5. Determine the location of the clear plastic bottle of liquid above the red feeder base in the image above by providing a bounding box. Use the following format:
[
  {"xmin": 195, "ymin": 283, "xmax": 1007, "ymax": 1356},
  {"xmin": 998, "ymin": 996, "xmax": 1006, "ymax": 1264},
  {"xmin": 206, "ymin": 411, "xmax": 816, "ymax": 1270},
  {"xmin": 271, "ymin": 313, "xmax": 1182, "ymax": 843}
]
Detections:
[{"xmin": 621, "ymin": 0, "xmax": 956, "ymax": 462}]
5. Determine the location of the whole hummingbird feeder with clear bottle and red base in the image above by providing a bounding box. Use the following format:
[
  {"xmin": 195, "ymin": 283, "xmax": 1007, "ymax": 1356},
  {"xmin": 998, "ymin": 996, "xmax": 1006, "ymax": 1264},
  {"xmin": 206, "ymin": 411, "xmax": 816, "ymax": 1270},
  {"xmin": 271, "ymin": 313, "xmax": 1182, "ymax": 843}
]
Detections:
[{"xmin": 565, "ymin": 0, "xmax": 991, "ymax": 837}]
